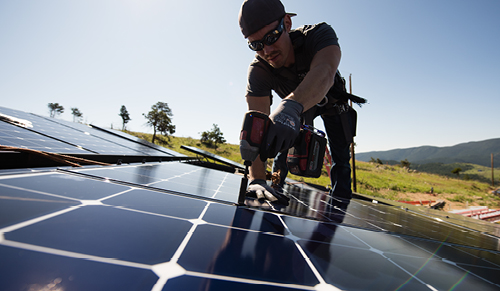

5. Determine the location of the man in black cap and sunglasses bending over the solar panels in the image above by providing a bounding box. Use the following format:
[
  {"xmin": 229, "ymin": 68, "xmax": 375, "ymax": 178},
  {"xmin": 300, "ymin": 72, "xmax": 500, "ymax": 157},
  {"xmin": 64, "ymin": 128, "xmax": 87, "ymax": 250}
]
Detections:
[{"xmin": 239, "ymin": 0, "xmax": 352, "ymax": 201}]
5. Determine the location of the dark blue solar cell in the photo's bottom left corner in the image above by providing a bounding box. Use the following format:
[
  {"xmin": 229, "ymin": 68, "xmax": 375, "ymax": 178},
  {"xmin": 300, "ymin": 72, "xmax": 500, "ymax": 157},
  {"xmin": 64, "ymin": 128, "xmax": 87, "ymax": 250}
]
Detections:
[{"xmin": 0, "ymin": 246, "xmax": 158, "ymax": 291}]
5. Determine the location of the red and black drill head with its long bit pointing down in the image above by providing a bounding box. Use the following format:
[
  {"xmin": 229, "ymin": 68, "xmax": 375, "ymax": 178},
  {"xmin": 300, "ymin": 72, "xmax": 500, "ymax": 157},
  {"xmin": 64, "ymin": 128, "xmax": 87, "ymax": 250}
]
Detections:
[{"xmin": 238, "ymin": 110, "xmax": 271, "ymax": 205}]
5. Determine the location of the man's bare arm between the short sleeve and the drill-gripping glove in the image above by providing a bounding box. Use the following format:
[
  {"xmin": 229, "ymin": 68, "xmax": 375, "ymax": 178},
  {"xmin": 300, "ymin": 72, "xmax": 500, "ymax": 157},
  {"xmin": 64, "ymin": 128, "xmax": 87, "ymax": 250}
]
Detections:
[{"xmin": 286, "ymin": 45, "xmax": 342, "ymax": 112}]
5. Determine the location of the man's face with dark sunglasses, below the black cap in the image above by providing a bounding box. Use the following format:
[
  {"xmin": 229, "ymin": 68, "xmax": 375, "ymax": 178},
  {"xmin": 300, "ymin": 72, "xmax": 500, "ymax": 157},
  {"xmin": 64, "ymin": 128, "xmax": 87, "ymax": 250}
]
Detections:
[{"xmin": 248, "ymin": 15, "xmax": 295, "ymax": 69}]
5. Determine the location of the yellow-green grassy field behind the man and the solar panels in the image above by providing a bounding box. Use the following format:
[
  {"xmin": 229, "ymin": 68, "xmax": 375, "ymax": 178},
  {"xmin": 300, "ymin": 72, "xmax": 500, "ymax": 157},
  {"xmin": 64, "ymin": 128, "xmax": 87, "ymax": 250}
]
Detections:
[{"xmin": 128, "ymin": 132, "xmax": 500, "ymax": 210}]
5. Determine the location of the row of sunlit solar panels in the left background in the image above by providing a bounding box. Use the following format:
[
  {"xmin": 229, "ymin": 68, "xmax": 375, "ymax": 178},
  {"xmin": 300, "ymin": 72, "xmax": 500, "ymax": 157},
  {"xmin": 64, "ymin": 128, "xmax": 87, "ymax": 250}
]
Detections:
[{"xmin": 0, "ymin": 107, "xmax": 185, "ymax": 157}]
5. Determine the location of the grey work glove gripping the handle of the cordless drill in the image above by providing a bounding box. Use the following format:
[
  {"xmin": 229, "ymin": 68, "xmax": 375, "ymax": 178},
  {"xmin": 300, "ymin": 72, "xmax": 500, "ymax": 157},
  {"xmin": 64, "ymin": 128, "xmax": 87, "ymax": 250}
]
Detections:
[{"xmin": 261, "ymin": 99, "xmax": 304, "ymax": 161}]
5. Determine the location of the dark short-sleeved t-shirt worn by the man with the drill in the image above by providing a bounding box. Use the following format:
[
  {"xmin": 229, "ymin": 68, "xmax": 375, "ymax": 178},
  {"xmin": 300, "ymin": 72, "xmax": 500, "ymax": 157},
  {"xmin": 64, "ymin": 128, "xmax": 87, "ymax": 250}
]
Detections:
[{"xmin": 247, "ymin": 22, "xmax": 339, "ymax": 101}]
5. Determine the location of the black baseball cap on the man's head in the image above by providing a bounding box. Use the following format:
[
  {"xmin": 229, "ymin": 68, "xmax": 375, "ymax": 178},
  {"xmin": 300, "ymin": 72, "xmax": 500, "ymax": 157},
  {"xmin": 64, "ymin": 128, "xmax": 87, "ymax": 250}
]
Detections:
[{"xmin": 239, "ymin": 0, "xmax": 297, "ymax": 38}]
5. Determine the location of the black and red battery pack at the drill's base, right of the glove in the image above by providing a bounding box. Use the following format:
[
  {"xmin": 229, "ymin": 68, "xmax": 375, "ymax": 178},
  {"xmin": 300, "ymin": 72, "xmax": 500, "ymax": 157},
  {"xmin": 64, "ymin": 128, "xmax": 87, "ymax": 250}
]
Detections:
[{"xmin": 287, "ymin": 125, "xmax": 326, "ymax": 178}]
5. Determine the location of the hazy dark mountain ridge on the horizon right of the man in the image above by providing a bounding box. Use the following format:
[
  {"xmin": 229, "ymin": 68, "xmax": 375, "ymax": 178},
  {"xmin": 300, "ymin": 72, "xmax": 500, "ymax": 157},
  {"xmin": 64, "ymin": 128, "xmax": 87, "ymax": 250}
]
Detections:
[{"xmin": 356, "ymin": 138, "xmax": 500, "ymax": 167}]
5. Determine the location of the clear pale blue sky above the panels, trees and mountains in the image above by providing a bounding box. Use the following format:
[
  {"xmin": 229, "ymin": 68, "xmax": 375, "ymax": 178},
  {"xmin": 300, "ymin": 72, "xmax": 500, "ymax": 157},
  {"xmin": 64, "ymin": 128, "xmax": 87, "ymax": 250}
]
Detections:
[{"xmin": 0, "ymin": 0, "xmax": 500, "ymax": 152}]
